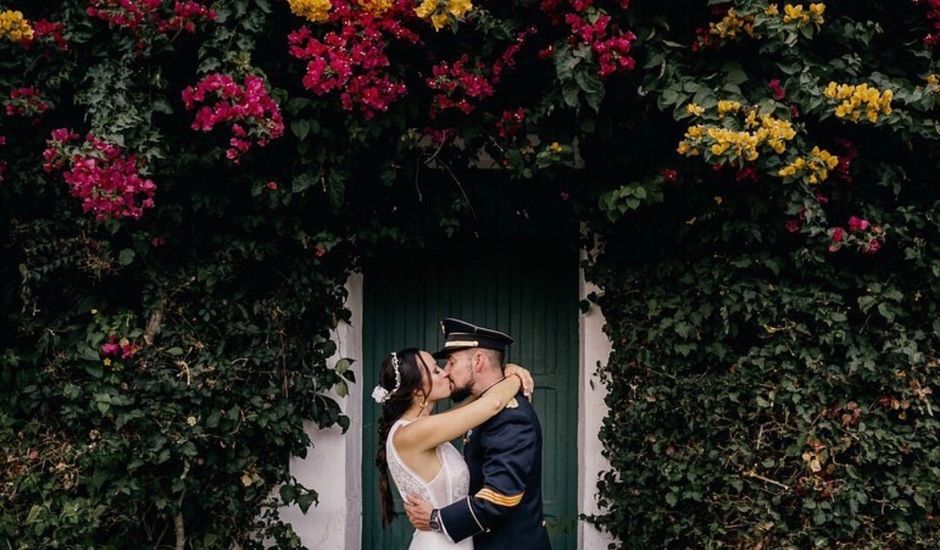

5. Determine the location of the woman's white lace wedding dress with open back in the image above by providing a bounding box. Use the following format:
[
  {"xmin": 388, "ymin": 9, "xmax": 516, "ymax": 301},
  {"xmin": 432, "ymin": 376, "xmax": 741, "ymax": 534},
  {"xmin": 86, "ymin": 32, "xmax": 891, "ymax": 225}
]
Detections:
[{"xmin": 385, "ymin": 420, "xmax": 473, "ymax": 550}]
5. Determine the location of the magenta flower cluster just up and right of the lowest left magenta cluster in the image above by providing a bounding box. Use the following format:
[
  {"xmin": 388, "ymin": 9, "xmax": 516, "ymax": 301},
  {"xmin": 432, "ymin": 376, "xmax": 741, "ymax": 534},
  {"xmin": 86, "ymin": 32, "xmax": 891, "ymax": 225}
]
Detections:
[{"xmin": 183, "ymin": 73, "xmax": 284, "ymax": 164}]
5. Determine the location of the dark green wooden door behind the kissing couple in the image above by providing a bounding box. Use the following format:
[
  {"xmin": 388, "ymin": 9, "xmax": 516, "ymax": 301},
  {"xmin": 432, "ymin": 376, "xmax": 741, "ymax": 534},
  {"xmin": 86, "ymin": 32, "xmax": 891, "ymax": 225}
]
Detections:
[{"xmin": 362, "ymin": 251, "xmax": 578, "ymax": 550}]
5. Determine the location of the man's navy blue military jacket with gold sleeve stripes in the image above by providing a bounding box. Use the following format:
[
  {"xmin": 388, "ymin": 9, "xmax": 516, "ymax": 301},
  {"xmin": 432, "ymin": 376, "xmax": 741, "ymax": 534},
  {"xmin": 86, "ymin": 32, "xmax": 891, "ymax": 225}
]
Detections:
[{"xmin": 440, "ymin": 393, "xmax": 551, "ymax": 550}]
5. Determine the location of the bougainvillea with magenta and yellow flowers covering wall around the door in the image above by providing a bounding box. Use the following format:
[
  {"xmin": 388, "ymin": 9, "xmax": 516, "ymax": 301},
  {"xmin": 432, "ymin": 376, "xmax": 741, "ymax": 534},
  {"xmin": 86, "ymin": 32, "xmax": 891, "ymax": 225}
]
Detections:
[{"xmin": 0, "ymin": 0, "xmax": 940, "ymax": 549}]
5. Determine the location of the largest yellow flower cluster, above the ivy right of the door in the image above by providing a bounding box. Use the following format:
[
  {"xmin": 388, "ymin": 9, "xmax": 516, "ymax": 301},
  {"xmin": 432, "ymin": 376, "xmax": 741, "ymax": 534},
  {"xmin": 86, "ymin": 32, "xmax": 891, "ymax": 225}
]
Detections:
[{"xmin": 676, "ymin": 105, "xmax": 796, "ymax": 161}]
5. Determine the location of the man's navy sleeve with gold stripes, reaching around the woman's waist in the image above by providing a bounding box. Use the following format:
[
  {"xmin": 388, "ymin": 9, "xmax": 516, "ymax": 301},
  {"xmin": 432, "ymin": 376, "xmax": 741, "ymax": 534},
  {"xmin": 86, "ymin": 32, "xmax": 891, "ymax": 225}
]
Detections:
[{"xmin": 440, "ymin": 409, "xmax": 538, "ymax": 542}]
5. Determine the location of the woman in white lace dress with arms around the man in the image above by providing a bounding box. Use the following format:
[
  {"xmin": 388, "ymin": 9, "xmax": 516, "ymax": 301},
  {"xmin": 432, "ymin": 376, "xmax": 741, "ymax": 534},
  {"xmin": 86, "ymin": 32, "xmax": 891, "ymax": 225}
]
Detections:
[{"xmin": 372, "ymin": 348, "xmax": 534, "ymax": 550}]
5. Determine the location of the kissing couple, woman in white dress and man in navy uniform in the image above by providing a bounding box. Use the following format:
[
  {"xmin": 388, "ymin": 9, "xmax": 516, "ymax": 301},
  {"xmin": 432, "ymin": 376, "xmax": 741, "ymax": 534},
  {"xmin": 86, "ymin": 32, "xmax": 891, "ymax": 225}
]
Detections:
[{"xmin": 372, "ymin": 318, "xmax": 551, "ymax": 550}]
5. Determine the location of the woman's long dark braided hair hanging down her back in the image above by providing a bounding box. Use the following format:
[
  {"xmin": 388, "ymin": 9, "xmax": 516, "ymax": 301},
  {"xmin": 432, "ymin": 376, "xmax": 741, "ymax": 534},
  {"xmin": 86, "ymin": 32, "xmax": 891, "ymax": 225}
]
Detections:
[{"xmin": 375, "ymin": 348, "xmax": 431, "ymax": 527}]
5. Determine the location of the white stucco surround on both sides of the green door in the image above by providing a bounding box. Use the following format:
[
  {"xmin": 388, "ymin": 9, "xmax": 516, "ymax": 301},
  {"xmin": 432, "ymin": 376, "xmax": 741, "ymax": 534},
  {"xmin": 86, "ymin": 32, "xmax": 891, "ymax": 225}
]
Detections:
[{"xmin": 280, "ymin": 250, "xmax": 613, "ymax": 550}]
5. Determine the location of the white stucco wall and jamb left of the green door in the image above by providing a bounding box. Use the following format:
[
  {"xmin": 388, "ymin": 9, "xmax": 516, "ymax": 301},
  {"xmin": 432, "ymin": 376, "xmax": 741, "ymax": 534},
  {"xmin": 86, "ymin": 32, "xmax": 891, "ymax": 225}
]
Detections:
[{"xmin": 281, "ymin": 273, "xmax": 362, "ymax": 550}]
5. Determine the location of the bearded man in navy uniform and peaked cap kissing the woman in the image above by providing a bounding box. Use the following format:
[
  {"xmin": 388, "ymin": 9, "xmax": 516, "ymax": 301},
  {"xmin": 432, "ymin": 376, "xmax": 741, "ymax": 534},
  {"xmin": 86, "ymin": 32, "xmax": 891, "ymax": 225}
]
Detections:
[{"xmin": 405, "ymin": 319, "xmax": 551, "ymax": 550}]
